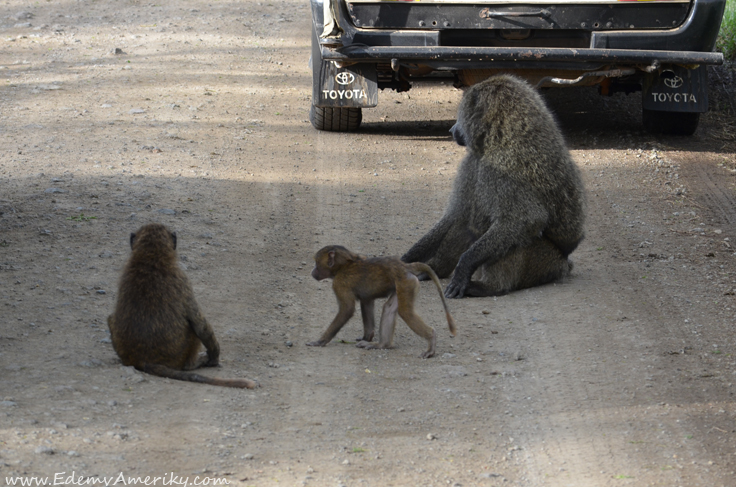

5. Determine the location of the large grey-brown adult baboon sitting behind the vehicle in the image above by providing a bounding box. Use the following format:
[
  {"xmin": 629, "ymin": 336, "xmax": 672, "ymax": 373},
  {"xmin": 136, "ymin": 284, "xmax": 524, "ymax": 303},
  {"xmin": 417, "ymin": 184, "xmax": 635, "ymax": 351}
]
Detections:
[{"xmin": 401, "ymin": 75, "xmax": 585, "ymax": 298}]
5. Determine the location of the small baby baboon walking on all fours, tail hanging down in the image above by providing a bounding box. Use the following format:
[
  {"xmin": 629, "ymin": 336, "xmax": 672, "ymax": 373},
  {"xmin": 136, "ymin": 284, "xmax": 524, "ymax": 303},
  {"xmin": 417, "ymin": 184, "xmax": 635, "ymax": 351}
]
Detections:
[{"xmin": 307, "ymin": 245, "xmax": 455, "ymax": 358}]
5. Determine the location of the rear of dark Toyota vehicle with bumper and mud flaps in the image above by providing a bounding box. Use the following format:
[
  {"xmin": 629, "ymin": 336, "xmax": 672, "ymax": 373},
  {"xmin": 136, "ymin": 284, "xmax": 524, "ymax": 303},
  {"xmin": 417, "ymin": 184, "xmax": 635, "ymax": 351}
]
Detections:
[{"xmin": 309, "ymin": 0, "xmax": 726, "ymax": 135}]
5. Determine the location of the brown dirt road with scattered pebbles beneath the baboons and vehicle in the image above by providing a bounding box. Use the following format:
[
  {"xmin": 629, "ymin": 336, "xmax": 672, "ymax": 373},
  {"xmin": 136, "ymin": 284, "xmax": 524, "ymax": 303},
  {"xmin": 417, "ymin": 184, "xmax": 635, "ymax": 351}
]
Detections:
[{"xmin": 0, "ymin": 0, "xmax": 736, "ymax": 487}]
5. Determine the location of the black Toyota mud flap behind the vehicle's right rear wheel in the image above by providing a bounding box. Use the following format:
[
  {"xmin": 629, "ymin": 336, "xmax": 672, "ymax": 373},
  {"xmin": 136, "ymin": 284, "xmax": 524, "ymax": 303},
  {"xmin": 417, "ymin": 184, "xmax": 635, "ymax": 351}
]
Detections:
[{"xmin": 642, "ymin": 66, "xmax": 708, "ymax": 113}]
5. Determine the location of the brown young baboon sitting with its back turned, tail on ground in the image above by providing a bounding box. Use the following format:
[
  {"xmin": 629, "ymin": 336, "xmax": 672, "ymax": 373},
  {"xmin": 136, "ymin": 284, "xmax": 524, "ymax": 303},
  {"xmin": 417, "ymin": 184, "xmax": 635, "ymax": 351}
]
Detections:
[{"xmin": 107, "ymin": 223, "xmax": 258, "ymax": 389}]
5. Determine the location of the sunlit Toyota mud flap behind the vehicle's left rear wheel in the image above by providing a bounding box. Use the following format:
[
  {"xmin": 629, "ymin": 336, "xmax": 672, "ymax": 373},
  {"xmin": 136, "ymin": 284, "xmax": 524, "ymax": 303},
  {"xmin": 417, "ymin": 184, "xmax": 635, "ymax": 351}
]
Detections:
[{"xmin": 312, "ymin": 61, "xmax": 378, "ymax": 108}]
